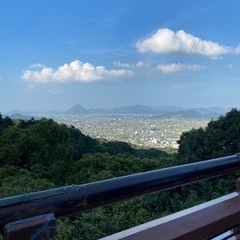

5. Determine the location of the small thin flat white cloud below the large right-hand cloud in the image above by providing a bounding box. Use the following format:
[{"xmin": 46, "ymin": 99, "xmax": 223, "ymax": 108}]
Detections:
[{"xmin": 156, "ymin": 63, "xmax": 206, "ymax": 74}]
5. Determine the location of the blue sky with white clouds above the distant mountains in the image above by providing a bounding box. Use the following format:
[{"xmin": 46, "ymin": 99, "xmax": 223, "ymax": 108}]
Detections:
[{"xmin": 0, "ymin": 0, "xmax": 240, "ymax": 113}]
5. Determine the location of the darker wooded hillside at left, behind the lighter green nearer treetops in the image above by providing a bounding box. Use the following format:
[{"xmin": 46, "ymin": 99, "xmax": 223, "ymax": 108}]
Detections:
[{"xmin": 0, "ymin": 113, "xmax": 171, "ymax": 175}]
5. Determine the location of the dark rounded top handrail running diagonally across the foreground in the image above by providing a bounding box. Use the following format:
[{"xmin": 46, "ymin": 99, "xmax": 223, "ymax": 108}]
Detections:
[{"xmin": 0, "ymin": 154, "xmax": 240, "ymax": 238}]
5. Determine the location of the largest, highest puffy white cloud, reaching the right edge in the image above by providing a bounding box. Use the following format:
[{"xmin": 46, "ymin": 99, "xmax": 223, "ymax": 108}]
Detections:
[{"xmin": 136, "ymin": 28, "xmax": 240, "ymax": 58}]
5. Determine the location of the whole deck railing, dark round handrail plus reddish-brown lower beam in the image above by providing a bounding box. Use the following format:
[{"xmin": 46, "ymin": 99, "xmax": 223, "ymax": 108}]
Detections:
[{"xmin": 0, "ymin": 154, "xmax": 240, "ymax": 240}]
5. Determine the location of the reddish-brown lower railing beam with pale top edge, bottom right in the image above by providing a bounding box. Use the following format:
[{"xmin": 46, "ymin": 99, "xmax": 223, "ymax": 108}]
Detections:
[{"xmin": 101, "ymin": 193, "xmax": 240, "ymax": 240}]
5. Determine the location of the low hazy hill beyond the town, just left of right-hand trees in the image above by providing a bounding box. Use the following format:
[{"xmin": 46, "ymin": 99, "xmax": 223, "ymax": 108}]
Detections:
[{"xmin": 161, "ymin": 110, "xmax": 221, "ymax": 119}]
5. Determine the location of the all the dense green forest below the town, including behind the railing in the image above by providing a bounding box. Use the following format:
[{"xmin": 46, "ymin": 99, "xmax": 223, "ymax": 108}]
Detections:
[{"xmin": 0, "ymin": 109, "xmax": 240, "ymax": 240}]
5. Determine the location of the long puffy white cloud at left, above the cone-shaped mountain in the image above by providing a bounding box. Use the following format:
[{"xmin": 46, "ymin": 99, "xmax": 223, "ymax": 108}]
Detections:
[{"xmin": 21, "ymin": 60, "xmax": 133, "ymax": 83}]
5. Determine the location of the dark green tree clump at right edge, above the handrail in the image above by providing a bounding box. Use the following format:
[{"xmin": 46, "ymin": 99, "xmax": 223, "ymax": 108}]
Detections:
[{"xmin": 178, "ymin": 109, "xmax": 240, "ymax": 163}]
